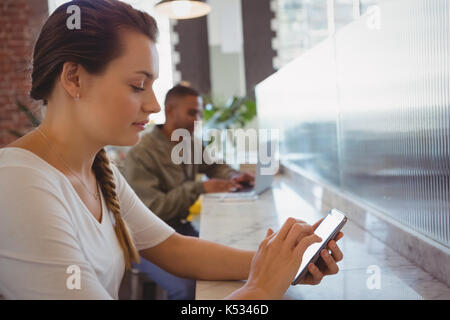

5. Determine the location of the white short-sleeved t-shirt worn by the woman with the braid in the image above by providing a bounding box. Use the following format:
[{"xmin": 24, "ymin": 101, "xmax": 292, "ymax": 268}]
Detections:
[{"xmin": 0, "ymin": 147, "xmax": 175, "ymax": 299}]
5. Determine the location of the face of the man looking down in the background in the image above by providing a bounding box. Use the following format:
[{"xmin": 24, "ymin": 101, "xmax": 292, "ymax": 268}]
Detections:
[{"xmin": 168, "ymin": 96, "xmax": 203, "ymax": 133}]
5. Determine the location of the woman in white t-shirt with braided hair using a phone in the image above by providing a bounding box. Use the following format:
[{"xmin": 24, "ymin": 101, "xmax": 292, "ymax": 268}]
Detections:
[{"xmin": 0, "ymin": 0, "xmax": 342, "ymax": 299}]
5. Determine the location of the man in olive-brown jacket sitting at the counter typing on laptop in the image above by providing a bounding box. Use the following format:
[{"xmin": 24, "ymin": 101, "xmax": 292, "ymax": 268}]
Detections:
[{"xmin": 124, "ymin": 85, "xmax": 254, "ymax": 299}]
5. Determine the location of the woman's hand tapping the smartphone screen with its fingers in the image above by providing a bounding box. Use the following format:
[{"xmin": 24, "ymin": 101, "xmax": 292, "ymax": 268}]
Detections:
[{"xmin": 244, "ymin": 218, "xmax": 321, "ymax": 299}]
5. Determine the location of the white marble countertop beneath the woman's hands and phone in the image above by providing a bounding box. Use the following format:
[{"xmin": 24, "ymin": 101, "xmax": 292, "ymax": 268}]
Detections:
[{"xmin": 196, "ymin": 177, "xmax": 450, "ymax": 300}]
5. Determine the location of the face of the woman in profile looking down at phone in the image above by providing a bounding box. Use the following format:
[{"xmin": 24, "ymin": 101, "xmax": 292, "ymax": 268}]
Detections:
[{"xmin": 79, "ymin": 31, "xmax": 161, "ymax": 146}]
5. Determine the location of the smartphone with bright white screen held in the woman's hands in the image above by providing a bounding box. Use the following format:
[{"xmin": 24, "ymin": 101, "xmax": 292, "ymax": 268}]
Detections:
[{"xmin": 292, "ymin": 209, "xmax": 347, "ymax": 285}]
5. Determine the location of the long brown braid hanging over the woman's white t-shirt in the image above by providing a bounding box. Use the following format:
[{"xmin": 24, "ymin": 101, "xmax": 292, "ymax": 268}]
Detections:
[{"xmin": 93, "ymin": 148, "xmax": 140, "ymax": 269}]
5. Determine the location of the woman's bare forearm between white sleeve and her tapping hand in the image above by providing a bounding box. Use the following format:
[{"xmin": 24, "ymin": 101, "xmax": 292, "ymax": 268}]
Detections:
[{"xmin": 139, "ymin": 233, "xmax": 255, "ymax": 280}]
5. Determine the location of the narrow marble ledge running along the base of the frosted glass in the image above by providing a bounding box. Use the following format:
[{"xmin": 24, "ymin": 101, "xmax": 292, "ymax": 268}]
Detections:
[{"xmin": 283, "ymin": 165, "xmax": 450, "ymax": 286}]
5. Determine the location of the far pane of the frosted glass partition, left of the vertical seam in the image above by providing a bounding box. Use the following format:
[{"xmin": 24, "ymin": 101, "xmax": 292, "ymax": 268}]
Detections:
[{"xmin": 257, "ymin": 41, "xmax": 339, "ymax": 184}]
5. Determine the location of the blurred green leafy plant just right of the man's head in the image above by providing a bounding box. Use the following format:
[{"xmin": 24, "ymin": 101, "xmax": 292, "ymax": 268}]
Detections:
[{"xmin": 203, "ymin": 96, "xmax": 256, "ymax": 129}]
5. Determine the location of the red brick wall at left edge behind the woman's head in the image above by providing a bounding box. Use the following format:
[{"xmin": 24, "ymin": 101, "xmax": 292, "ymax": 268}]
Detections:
[{"xmin": 0, "ymin": 0, "xmax": 48, "ymax": 147}]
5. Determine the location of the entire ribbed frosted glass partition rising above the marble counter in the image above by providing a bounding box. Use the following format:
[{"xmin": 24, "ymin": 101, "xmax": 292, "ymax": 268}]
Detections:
[{"xmin": 256, "ymin": 0, "xmax": 450, "ymax": 247}]
